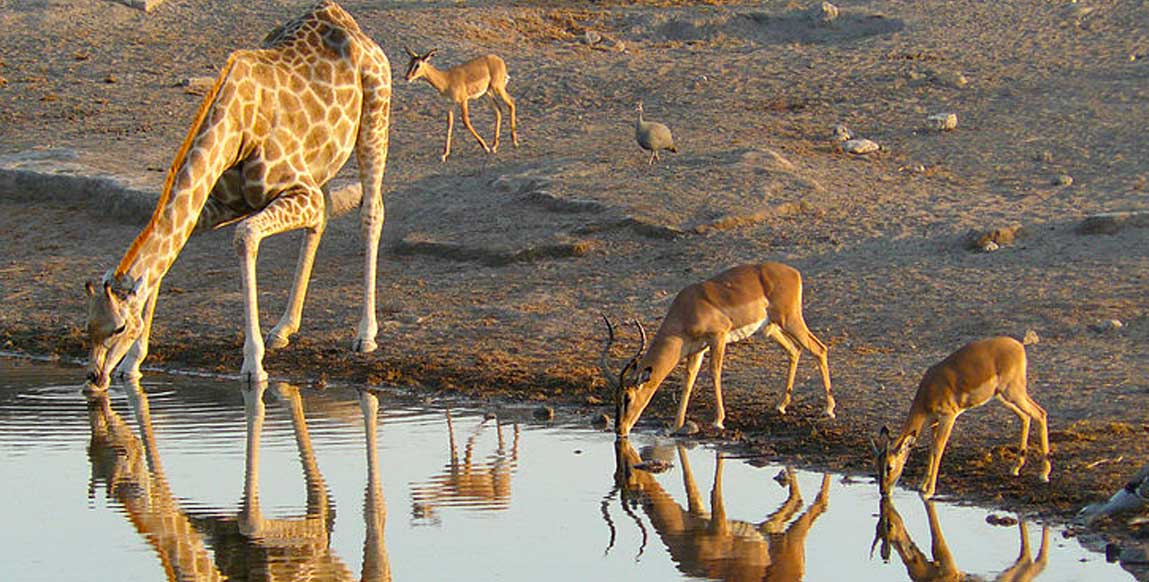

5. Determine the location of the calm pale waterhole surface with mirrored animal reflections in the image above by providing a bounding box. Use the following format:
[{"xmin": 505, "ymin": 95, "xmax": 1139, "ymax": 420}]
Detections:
[{"xmin": 0, "ymin": 358, "xmax": 1131, "ymax": 581}]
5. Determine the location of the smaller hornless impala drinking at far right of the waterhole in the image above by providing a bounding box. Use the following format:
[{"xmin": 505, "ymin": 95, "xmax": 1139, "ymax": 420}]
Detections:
[{"xmin": 871, "ymin": 336, "xmax": 1050, "ymax": 498}]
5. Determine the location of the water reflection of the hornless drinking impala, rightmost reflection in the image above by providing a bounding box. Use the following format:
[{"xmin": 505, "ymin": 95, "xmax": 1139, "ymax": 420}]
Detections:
[{"xmin": 871, "ymin": 497, "xmax": 1049, "ymax": 582}]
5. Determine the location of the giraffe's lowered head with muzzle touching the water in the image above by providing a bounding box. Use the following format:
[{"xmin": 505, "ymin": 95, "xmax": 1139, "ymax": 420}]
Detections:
[{"xmin": 84, "ymin": 274, "xmax": 144, "ymax": 390}]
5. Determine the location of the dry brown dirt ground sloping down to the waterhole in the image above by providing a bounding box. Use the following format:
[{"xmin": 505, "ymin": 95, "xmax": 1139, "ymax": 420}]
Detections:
[{"xmin": 0, "ymin": 0, "xmax": 1149, "ymax": 564}]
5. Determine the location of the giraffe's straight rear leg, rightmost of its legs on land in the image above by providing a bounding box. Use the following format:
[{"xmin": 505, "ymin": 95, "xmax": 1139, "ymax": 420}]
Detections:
[{"xmin": 353, "ymin": 64, "xmax": 390, "ymax": 354}]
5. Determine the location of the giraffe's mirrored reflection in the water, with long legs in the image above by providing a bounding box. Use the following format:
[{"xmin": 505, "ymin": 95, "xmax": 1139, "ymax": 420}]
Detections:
[{"xmin": 88, "ymin": 380, "xmax": 391, "ymax": 582}]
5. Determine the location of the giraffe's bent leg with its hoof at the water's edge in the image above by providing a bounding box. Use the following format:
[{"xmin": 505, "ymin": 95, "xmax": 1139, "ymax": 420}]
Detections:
[{"xmin": 236, "ymin": 184, "xmax": 325, "ymax": 382}]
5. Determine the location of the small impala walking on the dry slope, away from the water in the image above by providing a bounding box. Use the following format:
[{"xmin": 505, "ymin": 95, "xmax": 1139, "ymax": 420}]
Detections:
[{"xmin": 403, "ymin": 47, "xmax": 518, "ymax": 162}]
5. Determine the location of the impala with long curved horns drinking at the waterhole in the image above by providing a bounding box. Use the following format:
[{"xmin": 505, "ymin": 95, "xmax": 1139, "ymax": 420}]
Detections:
[{"xmin": 601, "ymin": 263, "xmax": 834, "ymax": 436}]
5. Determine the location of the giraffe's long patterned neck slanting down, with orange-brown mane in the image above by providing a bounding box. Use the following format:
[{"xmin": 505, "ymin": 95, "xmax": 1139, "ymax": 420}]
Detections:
[{"xmin": 115, "ymin": 55, "xmax": 241, "ymax": 297}]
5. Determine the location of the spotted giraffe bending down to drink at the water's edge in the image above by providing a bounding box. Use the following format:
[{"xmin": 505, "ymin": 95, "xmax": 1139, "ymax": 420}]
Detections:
[{"xmin": 85, "ymin": 0, "xmax": 391, "ymax": 390}]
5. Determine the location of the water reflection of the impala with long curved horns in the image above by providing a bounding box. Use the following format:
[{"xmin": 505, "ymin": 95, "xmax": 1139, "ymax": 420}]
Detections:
[{"xmin": 602, "ymin": 439, "xmax": 830, "ymax": 581}]
